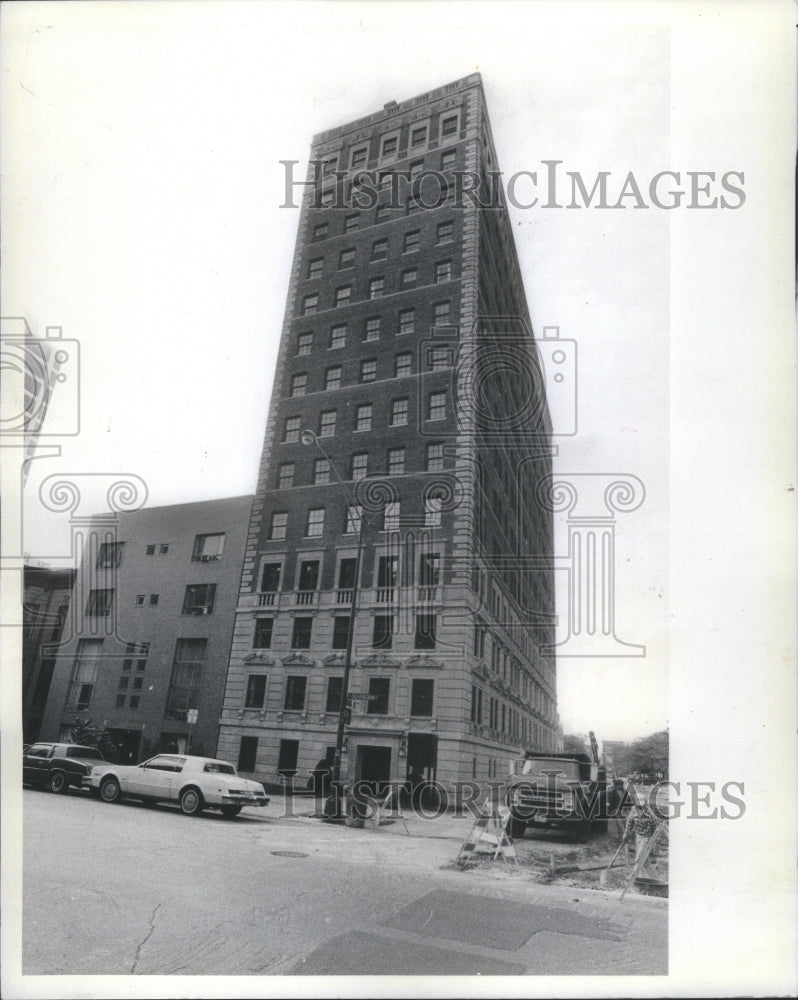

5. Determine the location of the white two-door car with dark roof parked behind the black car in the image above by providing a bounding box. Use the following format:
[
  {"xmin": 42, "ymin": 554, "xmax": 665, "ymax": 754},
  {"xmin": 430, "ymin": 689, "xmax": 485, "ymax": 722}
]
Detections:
[{"xmin": 83, "ymin": 753, "xmax": 269, "ymax": 817}]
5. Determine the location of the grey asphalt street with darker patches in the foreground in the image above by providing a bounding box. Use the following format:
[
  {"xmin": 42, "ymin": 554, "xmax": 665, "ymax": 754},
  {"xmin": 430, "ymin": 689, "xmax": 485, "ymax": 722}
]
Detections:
[{"xmin": 22, "ymin": 790, "xmax": 667, "ymax": 976}]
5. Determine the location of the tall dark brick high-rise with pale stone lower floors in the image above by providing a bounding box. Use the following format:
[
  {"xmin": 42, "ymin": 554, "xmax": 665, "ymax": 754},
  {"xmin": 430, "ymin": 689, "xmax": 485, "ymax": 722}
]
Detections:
[{"xmin": 219, "ymin": 75, "xmax": 556, "ymax": 782}]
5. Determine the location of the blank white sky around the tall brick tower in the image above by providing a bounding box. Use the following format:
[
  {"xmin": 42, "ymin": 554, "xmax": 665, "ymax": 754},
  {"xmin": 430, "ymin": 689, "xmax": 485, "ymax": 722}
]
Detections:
[{"xmin": 3, "ymin": 3, "xmax": 792, "ymax": 752}]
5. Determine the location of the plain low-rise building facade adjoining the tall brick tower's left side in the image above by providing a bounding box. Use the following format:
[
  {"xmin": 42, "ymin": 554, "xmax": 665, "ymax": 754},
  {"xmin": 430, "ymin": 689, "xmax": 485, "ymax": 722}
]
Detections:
[{"xmin": 39, "ymin": 496, "xmax": 252, "ymax": 763}]
